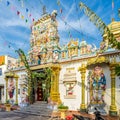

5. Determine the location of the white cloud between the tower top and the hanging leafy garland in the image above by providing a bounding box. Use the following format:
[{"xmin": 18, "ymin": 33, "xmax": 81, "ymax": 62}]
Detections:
[{"xmin": 58, "ymin": 16, "xmax": 99, "ymax": 37}]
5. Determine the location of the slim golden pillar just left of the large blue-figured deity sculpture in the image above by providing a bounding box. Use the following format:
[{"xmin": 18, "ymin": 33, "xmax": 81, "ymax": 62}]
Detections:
[{"xmin": 78, "ymin": 64, "xmax": 86, "ymax": 112}]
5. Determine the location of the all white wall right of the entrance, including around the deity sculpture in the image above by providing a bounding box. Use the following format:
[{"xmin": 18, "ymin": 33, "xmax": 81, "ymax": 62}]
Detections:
[{"xmin": 59, "ymin": 62, "xmax": 120, "ymax": 112}]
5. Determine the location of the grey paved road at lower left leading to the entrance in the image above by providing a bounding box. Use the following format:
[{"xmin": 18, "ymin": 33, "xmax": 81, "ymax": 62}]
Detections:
[{"xmin": 0, "ymin": 102, "xmax": 52, "ymax": 120}]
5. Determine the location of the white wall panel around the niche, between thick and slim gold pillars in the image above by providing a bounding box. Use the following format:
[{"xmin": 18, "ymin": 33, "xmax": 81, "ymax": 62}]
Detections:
[{"xmin": 59, "ymin": 61, "xmax": 87, "ymax": 110}]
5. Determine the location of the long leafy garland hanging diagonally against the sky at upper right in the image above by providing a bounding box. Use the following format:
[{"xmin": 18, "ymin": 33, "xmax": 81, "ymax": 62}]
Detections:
[{"xmin": 79, "ymin": 2, "xmax": 120, "ymax": 49}]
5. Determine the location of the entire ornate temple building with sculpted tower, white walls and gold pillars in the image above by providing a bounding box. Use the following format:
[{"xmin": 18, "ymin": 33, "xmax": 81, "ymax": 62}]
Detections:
[{"xmin": 5, "ymin": 11, "xmax": 120, "ymax": 115}]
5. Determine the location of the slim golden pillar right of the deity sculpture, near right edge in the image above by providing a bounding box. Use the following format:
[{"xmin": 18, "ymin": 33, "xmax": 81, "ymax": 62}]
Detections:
[{"xmin": 109, "ymin": 62, "xmax": 117, "ymax": 116}]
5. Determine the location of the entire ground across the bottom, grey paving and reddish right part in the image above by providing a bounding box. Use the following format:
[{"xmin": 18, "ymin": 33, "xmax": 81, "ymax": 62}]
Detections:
[{"xmin": 0, "ymin": 102, "xmax": 120, "ymax": 120}]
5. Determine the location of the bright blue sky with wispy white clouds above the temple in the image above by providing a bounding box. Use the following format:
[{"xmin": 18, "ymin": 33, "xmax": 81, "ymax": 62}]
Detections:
[{"xmin": 0, "ymin": 0, "xmax": 120, "ymax": 57}]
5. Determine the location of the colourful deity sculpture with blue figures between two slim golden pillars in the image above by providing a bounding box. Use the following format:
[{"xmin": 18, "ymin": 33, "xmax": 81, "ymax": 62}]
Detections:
[{"xmin": 88, "ymin": 66, "xmax": 106, "ymax": 104}]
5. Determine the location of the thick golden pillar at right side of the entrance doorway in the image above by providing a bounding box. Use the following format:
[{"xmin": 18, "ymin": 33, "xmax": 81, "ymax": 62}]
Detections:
[{"xmin": 51, "ymin": 66, "xmax": 61, "ymax": 103}]
